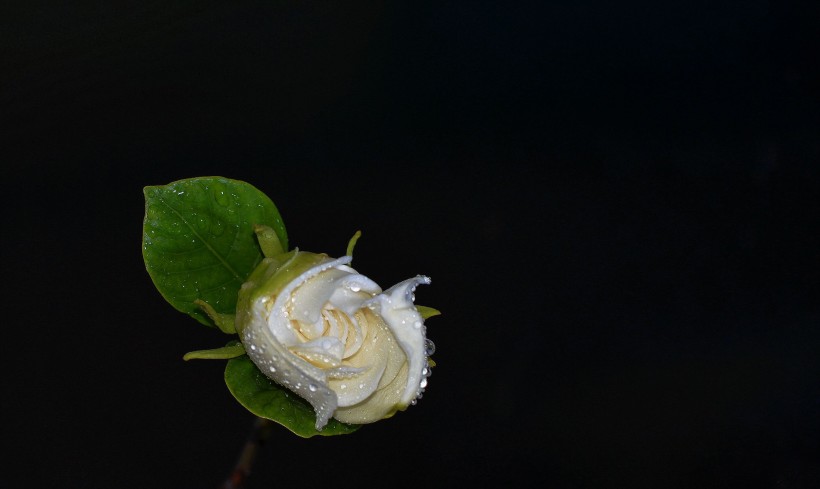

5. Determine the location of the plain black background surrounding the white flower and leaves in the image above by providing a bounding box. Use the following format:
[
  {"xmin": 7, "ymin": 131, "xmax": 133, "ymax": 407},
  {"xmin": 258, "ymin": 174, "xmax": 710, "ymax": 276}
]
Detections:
[{"xmin": 0, "ymin": 0, "xmax": 820, "ymax": 488}]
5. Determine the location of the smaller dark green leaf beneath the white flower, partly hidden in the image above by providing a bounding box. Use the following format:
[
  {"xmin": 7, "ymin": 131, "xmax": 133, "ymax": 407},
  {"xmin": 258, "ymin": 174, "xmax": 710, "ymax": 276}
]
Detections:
[{"xmin": 225, "ymin": 355, "xmax": 360, "ymax": 438}]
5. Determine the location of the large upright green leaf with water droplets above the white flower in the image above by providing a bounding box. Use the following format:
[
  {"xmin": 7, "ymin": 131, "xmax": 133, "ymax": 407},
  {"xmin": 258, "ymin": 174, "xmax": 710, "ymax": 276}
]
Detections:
[{"xmin": 142, "ymin": 177, "xmax": 287, "ymax": 326}]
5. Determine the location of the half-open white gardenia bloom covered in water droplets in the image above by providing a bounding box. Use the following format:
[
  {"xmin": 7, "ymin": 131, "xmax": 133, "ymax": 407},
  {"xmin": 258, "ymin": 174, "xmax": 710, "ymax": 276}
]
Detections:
[{"xmin": 236, "ymin": 250, "xmax": 432, "ymax": 429}]
